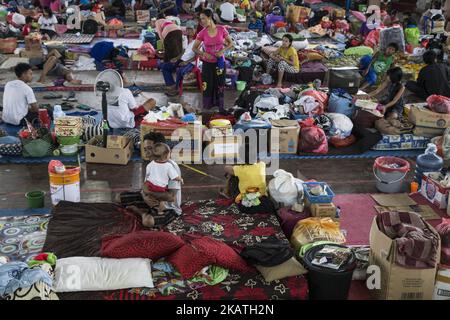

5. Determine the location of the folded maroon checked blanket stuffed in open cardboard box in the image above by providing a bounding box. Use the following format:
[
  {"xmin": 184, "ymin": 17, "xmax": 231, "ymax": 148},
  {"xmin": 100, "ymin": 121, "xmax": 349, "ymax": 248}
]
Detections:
[{"xmin": 377, "ymin": 211, "xmax": 439, "ymax": 269}]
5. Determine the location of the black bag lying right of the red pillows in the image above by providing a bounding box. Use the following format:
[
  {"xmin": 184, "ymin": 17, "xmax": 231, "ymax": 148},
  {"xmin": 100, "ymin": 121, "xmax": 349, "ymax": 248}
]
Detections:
[{"xmin": 241, "ymin": 236, "xmax": 294, "ymax": 267}]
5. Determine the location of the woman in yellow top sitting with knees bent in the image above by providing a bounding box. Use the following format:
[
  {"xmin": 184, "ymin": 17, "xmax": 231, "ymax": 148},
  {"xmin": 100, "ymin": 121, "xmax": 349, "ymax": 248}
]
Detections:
[{"xmin": 266, "ymin": 34, "xmax": 300, "ymax": 88}]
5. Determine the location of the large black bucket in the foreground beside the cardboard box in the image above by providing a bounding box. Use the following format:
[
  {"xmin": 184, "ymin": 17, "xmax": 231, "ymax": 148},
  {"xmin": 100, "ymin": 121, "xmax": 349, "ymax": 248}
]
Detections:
[{"xmin": 303, "ymin": 244, "xmax": 356, "ymax": 300}]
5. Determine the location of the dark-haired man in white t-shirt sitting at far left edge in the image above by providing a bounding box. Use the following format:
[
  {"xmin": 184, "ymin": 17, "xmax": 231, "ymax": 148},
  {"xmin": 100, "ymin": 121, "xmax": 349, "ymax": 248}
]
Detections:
[{"xmin": 2, "ymin": 63, "xmax": 39, "ymax": 125}]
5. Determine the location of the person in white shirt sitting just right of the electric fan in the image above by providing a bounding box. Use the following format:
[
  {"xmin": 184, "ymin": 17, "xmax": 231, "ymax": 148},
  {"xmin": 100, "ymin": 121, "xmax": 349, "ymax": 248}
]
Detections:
[{"xmin": 108, "ymin": 88, "xmax": 156, "ymax": 129}]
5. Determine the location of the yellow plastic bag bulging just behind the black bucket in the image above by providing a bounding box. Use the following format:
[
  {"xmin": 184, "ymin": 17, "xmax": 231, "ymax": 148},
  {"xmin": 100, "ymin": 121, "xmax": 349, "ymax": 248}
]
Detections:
[{"xmin": 291, "ymin": 218, "xmax": 345, "ymax": 251}]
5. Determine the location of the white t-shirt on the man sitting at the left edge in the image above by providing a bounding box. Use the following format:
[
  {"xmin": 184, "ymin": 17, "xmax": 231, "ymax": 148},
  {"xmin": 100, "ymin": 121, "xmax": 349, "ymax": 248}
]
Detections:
[{"xmin": 2, "ymin": 80, "xmax": 37, "ymax": 125}]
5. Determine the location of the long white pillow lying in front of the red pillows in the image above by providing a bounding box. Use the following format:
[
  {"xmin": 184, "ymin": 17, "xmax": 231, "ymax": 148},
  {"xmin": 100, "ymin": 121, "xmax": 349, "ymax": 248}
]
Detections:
[{"xmin": 54, "ymin": 257, "xmax": 154, "ymax": 292}]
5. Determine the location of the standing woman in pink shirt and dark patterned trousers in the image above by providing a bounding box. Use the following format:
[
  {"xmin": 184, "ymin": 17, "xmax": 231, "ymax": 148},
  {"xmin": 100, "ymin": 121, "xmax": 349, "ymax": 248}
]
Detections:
[{"xmin": 193, "ymin": 9, "xmax": 233, "ymax": 113}]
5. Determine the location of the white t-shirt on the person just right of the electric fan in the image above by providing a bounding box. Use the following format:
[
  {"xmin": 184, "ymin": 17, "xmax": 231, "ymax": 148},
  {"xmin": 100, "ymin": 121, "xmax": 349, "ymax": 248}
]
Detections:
[{"xmin": 108, "ymin": 89, "xmax": 138, "ymax": 129}]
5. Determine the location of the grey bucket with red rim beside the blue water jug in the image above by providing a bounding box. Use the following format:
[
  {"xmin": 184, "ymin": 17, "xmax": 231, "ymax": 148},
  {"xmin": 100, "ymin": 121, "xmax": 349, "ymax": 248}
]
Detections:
[{"xmin": 373, "ymin": 157, "xmax": 410, "ymax": 193}]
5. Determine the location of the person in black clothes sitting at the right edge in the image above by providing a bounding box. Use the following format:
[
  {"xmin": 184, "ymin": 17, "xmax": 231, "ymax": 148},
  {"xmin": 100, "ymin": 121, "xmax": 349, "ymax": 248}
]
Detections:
[{"xmin": 406, "ymin": 50, "xmax": 450, "ymax": 99}]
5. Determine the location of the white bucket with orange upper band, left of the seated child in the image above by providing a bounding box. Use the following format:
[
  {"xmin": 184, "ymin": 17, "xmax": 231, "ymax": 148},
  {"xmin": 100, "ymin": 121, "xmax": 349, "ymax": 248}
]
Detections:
[{"xmin": 49, "ymin": 167, "xmax": 80, "ymax": 205}]
